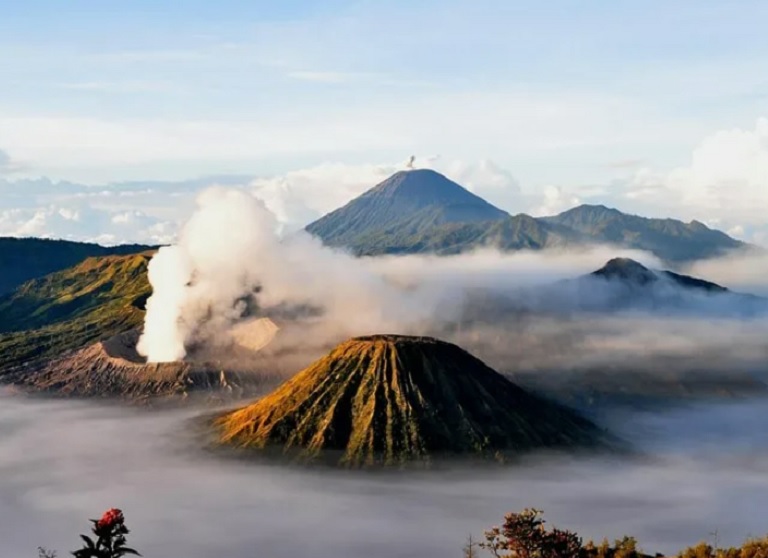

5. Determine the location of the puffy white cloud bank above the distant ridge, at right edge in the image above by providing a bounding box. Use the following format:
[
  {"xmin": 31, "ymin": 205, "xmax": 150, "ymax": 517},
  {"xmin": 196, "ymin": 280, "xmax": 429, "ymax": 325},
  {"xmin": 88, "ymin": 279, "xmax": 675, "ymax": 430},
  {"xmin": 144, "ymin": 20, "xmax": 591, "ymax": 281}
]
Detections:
[{"xmin": 512, "ymin": 118, "xmax": 768, "ymax": 244}]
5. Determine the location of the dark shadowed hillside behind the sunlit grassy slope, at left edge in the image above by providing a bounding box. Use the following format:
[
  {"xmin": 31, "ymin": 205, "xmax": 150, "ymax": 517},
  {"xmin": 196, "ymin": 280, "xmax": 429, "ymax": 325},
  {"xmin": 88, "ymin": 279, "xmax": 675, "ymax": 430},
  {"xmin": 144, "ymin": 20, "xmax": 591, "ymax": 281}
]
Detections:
[{"xmin": 0, "ymin": 237, "xmax": 150, "ymax": 295}]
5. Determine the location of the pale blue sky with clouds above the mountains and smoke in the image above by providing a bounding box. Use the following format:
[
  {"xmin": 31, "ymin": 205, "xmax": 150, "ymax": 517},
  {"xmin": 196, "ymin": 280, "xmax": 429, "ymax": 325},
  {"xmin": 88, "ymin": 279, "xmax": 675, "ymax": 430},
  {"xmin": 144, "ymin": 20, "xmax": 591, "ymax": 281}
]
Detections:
[{"xmin": 0, "ymin": 0, "xmax": 768, "ymax": 244}]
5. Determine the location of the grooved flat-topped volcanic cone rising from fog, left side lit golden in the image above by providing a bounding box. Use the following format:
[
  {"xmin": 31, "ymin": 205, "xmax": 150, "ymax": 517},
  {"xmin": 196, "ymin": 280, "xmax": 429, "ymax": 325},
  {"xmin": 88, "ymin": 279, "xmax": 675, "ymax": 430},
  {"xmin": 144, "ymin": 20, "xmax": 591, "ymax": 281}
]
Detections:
[{"xmin": 214, "ymin": 335, "xmax": 605, "ymax": 466}]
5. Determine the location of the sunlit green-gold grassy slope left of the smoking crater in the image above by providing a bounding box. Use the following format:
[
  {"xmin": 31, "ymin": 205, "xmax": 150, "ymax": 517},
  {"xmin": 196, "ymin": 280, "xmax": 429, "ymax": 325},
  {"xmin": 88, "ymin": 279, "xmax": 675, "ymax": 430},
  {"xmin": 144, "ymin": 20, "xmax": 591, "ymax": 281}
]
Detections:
[{"xmin": 0, "ymin": 252, "xmax": 151, "ymax": 370}]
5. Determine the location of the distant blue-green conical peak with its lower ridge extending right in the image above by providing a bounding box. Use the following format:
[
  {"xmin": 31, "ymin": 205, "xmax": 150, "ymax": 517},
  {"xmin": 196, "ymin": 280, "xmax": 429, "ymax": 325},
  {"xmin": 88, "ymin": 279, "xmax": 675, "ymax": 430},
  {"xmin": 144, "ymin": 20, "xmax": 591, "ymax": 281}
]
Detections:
[{"xmin": 306, "ymin": 170, "xmax": 754, "ymax": 264}]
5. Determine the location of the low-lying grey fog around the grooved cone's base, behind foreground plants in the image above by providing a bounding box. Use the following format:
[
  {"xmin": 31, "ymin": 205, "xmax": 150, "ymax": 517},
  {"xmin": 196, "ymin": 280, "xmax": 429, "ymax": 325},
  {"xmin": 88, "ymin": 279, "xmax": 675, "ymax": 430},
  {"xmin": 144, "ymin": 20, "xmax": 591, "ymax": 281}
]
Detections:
[{"xmin": 0, "ymin": 397, "xmax": 768, "ymax": 558}]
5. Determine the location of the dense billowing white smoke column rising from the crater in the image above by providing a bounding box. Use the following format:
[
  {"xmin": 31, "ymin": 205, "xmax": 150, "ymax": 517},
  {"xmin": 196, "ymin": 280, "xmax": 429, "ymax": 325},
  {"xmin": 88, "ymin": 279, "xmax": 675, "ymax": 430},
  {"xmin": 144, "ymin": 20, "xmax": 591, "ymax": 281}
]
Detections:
[{"xmin": 138, "ymin": 188, "xmax": 279, "ymax": 362}]
